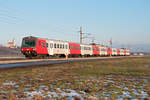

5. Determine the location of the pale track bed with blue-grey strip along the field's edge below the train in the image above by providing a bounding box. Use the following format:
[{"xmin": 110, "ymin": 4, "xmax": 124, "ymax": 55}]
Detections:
[{"xmin": 0, "ymin": 56, "xmax": 142, "ymax": 69}]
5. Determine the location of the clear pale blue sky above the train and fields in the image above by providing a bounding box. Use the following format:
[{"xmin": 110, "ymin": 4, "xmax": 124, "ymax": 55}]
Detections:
[{"xmin": 0, "ymin": 0, "xmax": 150, "ymax": 50}]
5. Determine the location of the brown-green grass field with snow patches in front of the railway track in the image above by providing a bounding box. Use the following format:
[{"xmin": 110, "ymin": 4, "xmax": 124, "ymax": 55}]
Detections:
[{"xmin": 0, "ymin": 57, "xmax": 150, "ymax": 100}]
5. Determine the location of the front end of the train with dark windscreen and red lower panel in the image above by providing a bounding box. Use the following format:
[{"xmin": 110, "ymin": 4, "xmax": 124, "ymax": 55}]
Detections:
[{"xmin": 21, "ymin": 36, "xmax": 37, "ymax": 58}]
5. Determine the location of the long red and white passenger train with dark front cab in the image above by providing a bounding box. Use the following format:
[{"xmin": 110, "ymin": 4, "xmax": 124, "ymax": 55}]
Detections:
[{"xmin": 21, "ymin": 36, "xmax": 130, "ymax": 58}]
